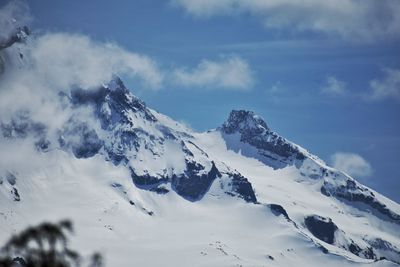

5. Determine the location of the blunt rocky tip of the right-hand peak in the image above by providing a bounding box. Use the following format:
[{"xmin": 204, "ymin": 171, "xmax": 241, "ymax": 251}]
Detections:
[{"xmin": 222, "ymin": 110, "xmax": 269, "ymax": 134}]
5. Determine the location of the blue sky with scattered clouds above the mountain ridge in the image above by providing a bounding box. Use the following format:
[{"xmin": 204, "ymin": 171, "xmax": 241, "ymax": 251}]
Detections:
[{"xmin": 10, "ymin": 0, "xmax": 400, "ymax": 202}]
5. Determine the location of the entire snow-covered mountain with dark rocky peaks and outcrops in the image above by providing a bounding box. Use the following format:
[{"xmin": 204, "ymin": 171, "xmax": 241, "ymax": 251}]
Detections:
[{"xmin": 0, "ymin": 29, "xmax": 400, "ymax": 266}]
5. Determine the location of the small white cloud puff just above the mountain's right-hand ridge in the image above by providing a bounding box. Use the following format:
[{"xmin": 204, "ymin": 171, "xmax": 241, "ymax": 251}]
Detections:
[{"xmin": 331, "ymin": 152, "xmax": 372, "ymax": 177}]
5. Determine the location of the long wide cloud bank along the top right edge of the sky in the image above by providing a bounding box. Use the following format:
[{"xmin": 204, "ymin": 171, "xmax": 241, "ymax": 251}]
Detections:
[{"xmin": 171, "ymin": 0, "xmax": 400, "ymax": 41}]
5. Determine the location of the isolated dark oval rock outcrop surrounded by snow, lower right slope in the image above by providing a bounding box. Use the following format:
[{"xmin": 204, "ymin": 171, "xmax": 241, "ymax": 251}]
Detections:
[{"xmin": 304, "ymin": 215, "xmax": 338, "ymax": 244}]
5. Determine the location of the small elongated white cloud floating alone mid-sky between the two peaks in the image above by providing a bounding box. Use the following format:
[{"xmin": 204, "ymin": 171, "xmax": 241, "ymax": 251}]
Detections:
[{"xmin": 173, "ymin": 56, "xmax": 254, "ymax": 90}]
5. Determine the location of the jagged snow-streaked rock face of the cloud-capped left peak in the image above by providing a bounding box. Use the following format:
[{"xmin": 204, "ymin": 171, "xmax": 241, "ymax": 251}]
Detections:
[{"xmin": 70, "ymin": 77, "xmax": 159, "ymax": 165}]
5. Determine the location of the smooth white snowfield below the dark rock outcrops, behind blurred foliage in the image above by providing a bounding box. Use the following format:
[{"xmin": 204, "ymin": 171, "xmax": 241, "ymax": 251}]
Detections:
[{"xmin": 0, "ymin": 151, "xmax": 395, "ymax": 266}]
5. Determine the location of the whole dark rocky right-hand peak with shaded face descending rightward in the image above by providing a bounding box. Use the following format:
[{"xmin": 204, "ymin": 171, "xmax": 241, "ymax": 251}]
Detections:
[{"xmin": 220, "ymin": 110, "xmax": 305, "ymax": 169}]
